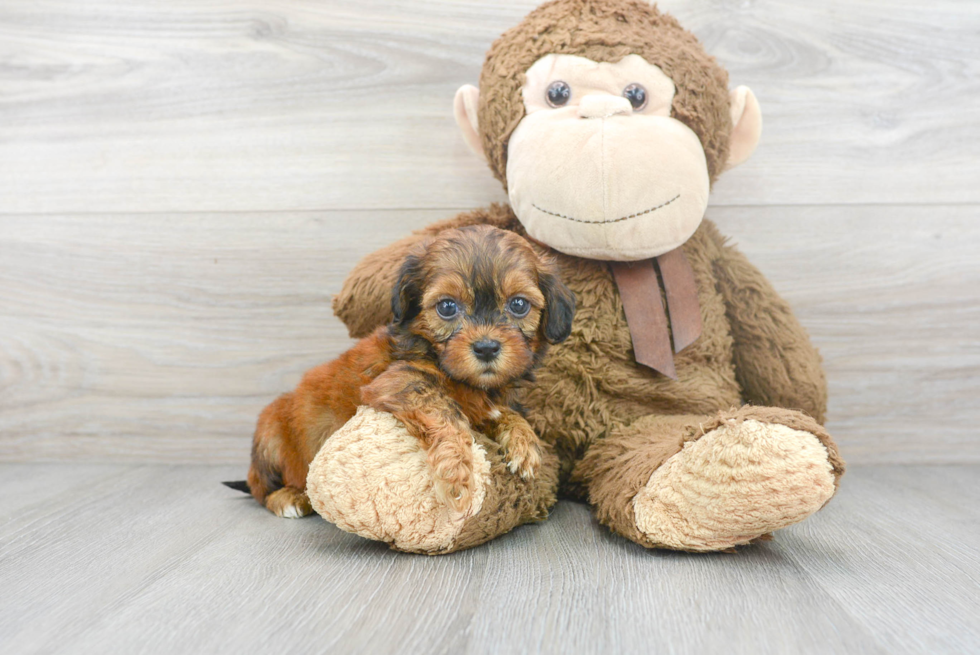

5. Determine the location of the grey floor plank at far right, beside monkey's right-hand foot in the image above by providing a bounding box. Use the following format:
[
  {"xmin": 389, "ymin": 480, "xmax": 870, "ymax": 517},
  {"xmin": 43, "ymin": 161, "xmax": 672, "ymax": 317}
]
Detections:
[{"xmin": 774, "ymin": 466, "xmax": 980, "ymax": 653}]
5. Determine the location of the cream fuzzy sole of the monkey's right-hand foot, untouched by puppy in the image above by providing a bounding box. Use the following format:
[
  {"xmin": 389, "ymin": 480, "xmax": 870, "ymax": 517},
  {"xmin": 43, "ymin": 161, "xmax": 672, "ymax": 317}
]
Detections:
[{"xmin": 633, "ymin": 420, "xmax": 834, "ymax": 551}]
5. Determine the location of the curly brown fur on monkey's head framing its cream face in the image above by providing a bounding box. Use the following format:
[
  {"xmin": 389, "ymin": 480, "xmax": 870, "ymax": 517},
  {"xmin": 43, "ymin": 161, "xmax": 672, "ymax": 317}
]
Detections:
[{"xmin": 478, "ymin": 0, "xmax": 732, "ymax": 188}]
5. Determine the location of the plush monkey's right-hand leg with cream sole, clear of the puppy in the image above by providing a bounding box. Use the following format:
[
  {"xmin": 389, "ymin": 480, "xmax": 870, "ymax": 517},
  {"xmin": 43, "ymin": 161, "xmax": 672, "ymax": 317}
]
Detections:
[{"xmin": 574, "ymin": 406, "xmax": 844, "ymax": 551}]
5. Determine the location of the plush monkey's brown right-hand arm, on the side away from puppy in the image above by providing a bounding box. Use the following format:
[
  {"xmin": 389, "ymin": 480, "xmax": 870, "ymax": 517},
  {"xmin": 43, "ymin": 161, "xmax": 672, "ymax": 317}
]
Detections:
[{"xmin": 715, "ymin": 229, "xmax": 827, "ymax": 424}]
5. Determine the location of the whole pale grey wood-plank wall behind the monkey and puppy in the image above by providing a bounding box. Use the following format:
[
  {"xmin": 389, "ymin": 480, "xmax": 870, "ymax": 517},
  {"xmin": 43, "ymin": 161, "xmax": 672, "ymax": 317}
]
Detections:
[{"xmin": 0, "ymin": 0, "xmax": 980, "ymax": 465}]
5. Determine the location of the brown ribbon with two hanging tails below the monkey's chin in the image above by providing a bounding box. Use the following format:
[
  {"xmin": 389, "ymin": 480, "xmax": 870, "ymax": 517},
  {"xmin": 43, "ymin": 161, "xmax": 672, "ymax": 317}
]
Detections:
[{"xmin": 609, "ymin": 248, "xmax": 701, "ymax": 380}]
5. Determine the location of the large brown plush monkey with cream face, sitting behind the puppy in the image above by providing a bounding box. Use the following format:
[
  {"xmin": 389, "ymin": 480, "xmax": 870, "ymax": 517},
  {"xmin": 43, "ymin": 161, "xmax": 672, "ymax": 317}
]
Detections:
[{"xmin": 308, "ymin": 0, "xmax": 844, "ymax": 554}]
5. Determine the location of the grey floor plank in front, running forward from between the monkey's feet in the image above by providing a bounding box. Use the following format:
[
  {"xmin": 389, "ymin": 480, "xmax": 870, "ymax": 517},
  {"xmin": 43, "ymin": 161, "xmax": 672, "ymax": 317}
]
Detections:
[{"xmin": 467, "ymin": 503, "xmax": 884, "ymax": 653}]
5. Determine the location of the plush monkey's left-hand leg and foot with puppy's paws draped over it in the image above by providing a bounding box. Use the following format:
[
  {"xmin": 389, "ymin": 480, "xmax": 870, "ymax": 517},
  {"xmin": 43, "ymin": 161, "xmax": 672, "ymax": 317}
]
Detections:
[{"xmin": 307, "ymin": 407, "xmax": 558, "ymax": 555}]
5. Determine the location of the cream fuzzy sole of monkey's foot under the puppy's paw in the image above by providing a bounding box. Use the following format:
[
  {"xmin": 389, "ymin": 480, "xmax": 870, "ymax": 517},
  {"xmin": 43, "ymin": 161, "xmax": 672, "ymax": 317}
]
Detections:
[{"xmin": 306, "ymin": 407, "xmax": 490, "ymax": 553}]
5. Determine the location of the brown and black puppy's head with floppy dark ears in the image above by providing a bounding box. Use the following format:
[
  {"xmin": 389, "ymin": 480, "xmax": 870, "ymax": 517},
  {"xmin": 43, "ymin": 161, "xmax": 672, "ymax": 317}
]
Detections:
[{"xmin": 392, "ymin": 226, "xmax": 575, "ymax": 389}]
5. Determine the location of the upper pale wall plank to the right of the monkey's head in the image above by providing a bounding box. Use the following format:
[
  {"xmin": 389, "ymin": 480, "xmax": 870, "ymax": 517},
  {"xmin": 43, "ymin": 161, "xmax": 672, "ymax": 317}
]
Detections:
[{"xmin": 658, "ymin": 0, "xmax": 980, "ymax": 205}]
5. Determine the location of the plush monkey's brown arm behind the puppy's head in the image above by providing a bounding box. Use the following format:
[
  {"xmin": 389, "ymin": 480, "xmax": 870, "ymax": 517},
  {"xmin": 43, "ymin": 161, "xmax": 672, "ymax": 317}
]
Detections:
[{"xmin": 333, "ymin": 204, "xmax": 518, "ymax": 339}]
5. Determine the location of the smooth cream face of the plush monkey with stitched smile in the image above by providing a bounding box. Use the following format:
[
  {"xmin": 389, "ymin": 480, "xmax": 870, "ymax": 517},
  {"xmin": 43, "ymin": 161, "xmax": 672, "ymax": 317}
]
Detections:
[{"xmin": 507, "ymin": 55, "xmax": 709, "ymax": 260}]
